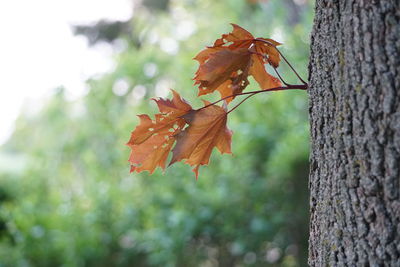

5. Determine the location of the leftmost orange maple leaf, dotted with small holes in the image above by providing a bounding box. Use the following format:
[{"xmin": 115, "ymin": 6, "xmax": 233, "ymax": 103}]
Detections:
[{"xmin": 127, "ymin": 90, "xmax": 192, "ymax": 173}]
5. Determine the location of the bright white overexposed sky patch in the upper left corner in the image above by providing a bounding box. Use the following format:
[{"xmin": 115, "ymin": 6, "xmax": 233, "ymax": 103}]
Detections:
[{"xmin": 0, "ymin": 0, "xmax": 133, "ymax": 144}]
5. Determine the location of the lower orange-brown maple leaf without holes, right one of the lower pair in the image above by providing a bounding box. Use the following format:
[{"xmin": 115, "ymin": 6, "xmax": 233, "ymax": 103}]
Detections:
[{"xmin": 170, "ymin": 101, "xmax": 232, "ymax": 179}]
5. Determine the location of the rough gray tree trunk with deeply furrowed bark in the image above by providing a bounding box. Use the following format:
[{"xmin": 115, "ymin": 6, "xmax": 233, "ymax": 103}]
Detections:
[{"xmin": 309, "ymin": 0, "xmax": 400, "ymax": 266}]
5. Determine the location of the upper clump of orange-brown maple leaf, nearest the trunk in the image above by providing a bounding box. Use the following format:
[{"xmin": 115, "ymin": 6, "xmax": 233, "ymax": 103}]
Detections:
[{"xmin": 194, "ymin": 24, "xmax": 281, "ymax": 102}]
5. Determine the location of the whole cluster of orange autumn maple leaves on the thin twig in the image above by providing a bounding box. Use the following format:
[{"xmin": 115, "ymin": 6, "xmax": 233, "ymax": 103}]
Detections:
[{"xmin": 127, "ymin": 24, "xmax": 281, "ymax": 179}]
